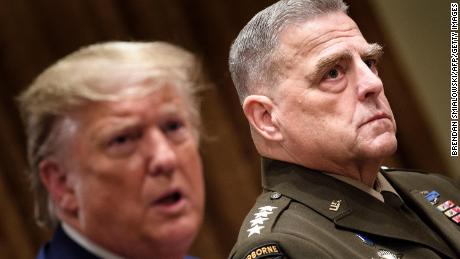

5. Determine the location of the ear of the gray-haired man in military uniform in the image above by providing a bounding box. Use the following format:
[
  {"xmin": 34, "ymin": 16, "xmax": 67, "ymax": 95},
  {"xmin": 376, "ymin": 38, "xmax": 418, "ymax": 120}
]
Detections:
[{"xmin": 243, "ymin": 95, "xmax": 283, "ymax": 141}]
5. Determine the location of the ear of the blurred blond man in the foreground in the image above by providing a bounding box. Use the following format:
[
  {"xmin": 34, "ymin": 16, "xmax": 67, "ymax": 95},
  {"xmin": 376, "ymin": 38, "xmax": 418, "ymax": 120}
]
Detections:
[{"xmin": 38, "ymin": 159, "xmax": 78, "ymax": 214}]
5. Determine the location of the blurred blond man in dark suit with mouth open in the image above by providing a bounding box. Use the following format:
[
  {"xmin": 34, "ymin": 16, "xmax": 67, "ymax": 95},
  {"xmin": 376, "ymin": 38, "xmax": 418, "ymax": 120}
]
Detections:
[{"xmin": 19, "ymin": 42, "xmax": 204, "ymax": 259}]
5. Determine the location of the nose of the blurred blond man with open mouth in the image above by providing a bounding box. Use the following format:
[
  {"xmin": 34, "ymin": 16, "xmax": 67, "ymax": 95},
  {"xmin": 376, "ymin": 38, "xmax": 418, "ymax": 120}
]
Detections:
[{"xmin": 147, "ymin": 129, "xmax": 177, "ymax": 176}]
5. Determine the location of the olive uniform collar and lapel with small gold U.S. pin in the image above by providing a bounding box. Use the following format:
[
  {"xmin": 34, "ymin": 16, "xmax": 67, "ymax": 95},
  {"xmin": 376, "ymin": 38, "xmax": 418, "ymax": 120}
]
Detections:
[{"xmin": 262, "ymin": 158, "xmax": 452, "ymax": 258}]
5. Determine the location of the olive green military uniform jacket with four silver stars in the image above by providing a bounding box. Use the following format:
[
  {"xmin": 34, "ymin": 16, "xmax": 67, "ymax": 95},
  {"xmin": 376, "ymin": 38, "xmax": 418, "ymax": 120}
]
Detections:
[{"xmin": 229, "ymin": 158, "xmax": 460, "ymax": 259}]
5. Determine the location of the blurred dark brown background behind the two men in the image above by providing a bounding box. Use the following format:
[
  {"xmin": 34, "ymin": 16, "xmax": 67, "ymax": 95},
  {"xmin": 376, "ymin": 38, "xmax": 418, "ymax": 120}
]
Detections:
[{"xmin": 0, "ymin": 0, "xmax": 460, "ymax": 259}]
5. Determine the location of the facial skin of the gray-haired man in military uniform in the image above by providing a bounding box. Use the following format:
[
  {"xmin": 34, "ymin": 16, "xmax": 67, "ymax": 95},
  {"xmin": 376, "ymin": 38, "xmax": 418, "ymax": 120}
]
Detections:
[{"xmin": 244, "ymin": 13, "xmax": 397, "ymax": 185}]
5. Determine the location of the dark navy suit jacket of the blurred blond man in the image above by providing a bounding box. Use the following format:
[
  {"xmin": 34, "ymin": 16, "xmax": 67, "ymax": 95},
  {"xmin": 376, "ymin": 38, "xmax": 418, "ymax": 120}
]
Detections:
[{"xmin": 36, "ymin": 226, "xmax": 198, "ymax": 259}]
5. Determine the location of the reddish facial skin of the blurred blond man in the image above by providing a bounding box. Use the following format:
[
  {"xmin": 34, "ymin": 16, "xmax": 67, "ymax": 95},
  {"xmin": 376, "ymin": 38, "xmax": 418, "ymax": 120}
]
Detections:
[{"xmin": 42, "ymin": 86, "xmax": 204, "ymax": 258}]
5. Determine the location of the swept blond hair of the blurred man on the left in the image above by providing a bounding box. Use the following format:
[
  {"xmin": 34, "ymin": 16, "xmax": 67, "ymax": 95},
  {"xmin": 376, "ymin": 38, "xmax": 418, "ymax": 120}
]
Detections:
[{"xmin": 18, "ymin": 42, "xmax": 206, "ymax": 227}]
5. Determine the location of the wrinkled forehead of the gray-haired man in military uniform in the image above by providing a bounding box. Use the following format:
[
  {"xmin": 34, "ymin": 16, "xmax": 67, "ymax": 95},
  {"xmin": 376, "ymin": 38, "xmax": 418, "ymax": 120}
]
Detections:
[{"xmin": 279, "ymin": 12, "xmax": 367, "ymax": 60}]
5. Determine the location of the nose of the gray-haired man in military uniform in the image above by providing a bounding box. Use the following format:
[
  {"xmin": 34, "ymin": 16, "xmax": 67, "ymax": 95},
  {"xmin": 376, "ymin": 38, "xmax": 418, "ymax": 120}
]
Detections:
[{"xmin": 356, "ymin": 60, "xmax": 383, "ymax": 101}]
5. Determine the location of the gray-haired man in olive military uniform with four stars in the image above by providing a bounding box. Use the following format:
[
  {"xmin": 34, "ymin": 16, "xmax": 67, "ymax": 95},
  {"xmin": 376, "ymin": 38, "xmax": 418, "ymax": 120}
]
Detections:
[{"xmin": 229, "ymin": 0, "xmax": 460, "ymax": 259}]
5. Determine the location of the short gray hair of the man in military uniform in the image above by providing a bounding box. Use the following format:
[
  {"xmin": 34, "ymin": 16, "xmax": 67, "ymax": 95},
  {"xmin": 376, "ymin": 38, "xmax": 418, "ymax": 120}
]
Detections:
[{"xmin": 229, "ymin": 0, "xmax": 348, "ymax": 103}]
